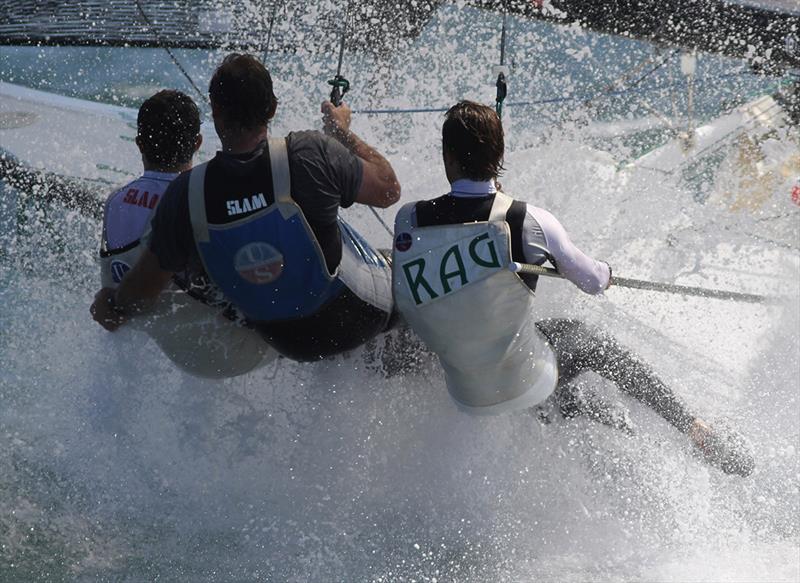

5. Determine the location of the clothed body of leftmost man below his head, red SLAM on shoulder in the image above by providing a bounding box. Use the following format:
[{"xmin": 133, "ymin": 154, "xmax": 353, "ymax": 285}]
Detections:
[{"xmin": 100, "ymin": 173, "xmax": 277, "ymax": 379}]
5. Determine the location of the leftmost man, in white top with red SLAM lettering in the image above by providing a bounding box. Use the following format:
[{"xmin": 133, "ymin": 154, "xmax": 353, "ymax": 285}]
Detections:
[{"xmin": 100, "ymin": 90, "xmax": 277, "ymax": 378}]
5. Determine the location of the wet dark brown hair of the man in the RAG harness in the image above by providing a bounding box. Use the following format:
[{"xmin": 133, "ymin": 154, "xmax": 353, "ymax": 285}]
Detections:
[{"xmin": 442, "ymin": 101, "xmax": 505, "ymax": 180}]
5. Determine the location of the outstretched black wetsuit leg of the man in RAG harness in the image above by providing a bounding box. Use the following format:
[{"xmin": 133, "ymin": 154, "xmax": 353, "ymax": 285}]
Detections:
[{"xmin": 536, "ymin": 319, "xmax": 694, "ymax": 433}]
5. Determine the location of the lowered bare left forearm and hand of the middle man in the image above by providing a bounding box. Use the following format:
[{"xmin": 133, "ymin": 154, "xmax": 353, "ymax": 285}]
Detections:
[{"xmin": 89, "ymin": 249, "xmax": 173, "ymax": 332}]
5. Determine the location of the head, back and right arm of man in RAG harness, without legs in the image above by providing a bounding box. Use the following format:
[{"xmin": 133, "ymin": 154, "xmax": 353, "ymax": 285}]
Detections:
[{"xmin": 393, "ymin": 102, "xmax": 608, "ymax": 414}]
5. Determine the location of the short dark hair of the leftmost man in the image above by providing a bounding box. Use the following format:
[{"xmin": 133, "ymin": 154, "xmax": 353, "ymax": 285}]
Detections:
[{"xmin": 136, "ymin": 90, "xmax": 200, "ymax": 169}]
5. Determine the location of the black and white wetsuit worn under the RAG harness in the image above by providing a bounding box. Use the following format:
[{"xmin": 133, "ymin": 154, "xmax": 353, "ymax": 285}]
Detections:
[{"xmin": 400, "ymin": 180, "xmax": 693, "ymax": 432}]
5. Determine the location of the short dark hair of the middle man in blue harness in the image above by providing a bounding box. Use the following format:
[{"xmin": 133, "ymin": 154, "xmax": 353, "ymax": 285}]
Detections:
[{"xmin": 208, "ymin": 53, "xmax": 278, "ymax": 129}]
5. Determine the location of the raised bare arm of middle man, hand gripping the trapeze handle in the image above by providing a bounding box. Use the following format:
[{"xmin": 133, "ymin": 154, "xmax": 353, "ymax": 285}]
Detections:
[{"xmin": 322, "ymin": 101, "xmax": 400, "ymax": 208}]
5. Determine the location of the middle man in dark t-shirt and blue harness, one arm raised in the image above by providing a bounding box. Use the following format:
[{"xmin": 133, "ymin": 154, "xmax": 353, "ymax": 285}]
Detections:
[{"xmin": 93, "ymin": 54, "xmax": 400, "ymax": 361}]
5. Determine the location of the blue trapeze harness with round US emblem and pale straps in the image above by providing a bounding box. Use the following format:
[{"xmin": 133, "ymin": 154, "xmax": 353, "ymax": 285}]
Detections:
[{"xmin": 184, "ymin": 138, "xmax": 392, "ymax": 361}]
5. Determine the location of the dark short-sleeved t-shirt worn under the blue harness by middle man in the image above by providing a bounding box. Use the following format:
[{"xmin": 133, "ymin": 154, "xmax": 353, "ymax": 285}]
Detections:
[{"xmin": 150, "ymin": 131, "xmax": 364, "ymax": 273}]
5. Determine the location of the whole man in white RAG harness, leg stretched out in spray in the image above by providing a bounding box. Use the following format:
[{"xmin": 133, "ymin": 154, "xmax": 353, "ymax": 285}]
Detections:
[{"xmin": 393, "ymin": 101, "xmax": 753, "ymax": 476}]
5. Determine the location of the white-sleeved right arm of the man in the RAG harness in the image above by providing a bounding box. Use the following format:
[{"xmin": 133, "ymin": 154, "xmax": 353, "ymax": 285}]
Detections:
[{"xmin": 524, "ymin": 205, "xmax": 611, "ymax": 294}]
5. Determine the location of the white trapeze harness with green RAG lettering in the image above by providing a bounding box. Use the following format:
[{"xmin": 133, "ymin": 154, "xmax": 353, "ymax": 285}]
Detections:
[{"xmin": 393, "ymin": 192, "xmax": 558, "ymax": 415}]
